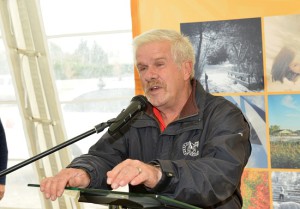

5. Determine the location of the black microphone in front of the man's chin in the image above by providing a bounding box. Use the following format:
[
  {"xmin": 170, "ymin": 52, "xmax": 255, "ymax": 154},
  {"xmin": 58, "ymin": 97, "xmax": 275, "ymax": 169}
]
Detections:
[{"xmin": 108, "ymin": 95, "xmax": 148, "ymax": 135}]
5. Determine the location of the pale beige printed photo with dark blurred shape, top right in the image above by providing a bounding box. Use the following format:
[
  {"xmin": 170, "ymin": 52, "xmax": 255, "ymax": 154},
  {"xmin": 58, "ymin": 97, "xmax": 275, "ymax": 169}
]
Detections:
[{"xmin": 264, "ymin": 14, "xmax": 300, "ymax": 92}]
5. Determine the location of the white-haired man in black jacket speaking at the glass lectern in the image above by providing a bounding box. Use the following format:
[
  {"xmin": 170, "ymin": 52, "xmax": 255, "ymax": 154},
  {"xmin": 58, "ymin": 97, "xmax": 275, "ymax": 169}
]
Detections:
[{"xmin": 41, "ymin": 30, "xmax": 251, "ymax": 209}]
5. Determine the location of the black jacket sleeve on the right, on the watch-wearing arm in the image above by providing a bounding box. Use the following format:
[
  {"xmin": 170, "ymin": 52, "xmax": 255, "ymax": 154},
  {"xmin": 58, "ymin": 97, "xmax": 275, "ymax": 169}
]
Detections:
[{"xmin": 151, "ymin": 99, "xmax": 251, "ymax": 207}]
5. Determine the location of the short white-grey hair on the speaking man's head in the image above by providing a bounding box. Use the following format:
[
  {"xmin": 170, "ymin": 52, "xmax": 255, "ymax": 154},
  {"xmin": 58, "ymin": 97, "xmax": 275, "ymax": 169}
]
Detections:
[{"xmin": 133, "ymin": 29, "xmax": 195, "ymax": 79}]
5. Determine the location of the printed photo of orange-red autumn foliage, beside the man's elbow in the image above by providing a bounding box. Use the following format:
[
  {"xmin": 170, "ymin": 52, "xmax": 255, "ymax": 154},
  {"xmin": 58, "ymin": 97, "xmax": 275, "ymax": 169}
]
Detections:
[{"xmin": 241, "ymin": 169, "xmax": 270, "ymax": 209}]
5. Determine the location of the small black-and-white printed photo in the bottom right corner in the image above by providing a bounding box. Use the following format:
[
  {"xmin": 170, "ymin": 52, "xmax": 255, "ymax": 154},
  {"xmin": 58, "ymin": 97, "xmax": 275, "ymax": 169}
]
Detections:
[{"xmin": 271, "ymin": 172, "xmax": 300, "ymax": 209}]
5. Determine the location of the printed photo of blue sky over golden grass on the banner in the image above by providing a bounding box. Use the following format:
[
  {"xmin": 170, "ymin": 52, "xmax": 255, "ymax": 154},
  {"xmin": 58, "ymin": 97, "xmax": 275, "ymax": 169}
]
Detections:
[{"xmin": 268, "ymin": 94, "xmax": 300, "ymax": 168}]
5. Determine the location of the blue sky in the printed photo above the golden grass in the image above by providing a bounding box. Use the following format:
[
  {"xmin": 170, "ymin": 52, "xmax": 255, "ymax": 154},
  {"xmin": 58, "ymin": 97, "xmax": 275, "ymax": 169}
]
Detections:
[{"xmin": 268, "ymin": 94, "xmax": 300, "ymax": 131}]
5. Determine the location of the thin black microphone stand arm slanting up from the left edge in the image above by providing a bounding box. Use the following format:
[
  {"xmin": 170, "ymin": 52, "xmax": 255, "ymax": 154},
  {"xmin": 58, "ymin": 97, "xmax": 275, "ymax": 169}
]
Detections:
[{"xmin": 0, "ymin": 119, "xmax": 114, "ymax": 177}]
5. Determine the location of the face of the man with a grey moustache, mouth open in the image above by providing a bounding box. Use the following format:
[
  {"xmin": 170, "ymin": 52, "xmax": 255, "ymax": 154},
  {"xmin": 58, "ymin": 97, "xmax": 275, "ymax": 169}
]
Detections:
[{"xmin": 136, "ymin": 41, "xmax": 189, "ymax": 109}]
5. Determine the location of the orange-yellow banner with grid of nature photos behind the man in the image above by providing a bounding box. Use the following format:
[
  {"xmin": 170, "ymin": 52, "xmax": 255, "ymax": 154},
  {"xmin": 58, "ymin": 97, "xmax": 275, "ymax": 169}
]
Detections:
[{"xmin": 131, "ymin": 0, "xmax": 300, "ymax": 209}]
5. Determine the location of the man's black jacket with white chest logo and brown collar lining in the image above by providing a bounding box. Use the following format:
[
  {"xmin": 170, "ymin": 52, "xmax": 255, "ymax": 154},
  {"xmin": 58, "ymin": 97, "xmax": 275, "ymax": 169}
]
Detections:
[{"xmin": 69, "ymin": 81, "xmax": 251, "ymax": 209}]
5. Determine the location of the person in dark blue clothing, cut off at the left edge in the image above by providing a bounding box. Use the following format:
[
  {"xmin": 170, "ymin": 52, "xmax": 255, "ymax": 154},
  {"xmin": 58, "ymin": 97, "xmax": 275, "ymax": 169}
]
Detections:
[{"xmin": 0, "ymin": 119, "xmax": 8, "ymax": 185}]
